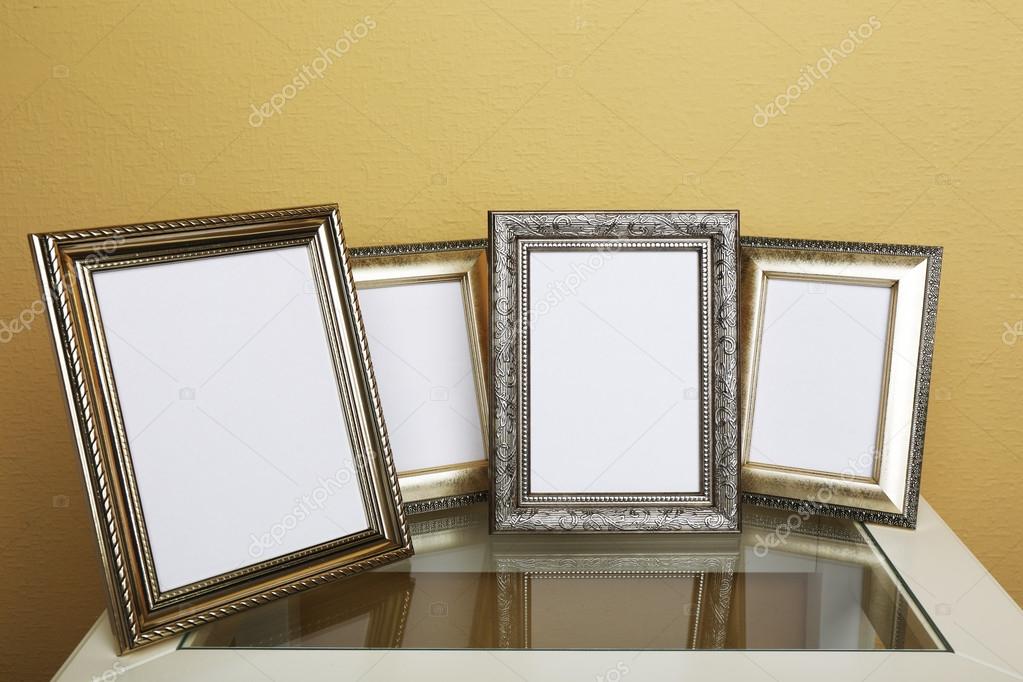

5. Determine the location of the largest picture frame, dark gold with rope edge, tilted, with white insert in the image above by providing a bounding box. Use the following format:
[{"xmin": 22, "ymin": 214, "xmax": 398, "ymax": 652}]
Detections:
[{"xmin": 30, "ymin": 204, "xmax": 412, "ymax": 652}]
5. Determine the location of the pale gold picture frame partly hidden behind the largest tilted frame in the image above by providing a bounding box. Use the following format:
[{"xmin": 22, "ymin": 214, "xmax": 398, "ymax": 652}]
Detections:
[{"xmin": 352, "ymin": 239, "xmax": 490, "ymax": 514}]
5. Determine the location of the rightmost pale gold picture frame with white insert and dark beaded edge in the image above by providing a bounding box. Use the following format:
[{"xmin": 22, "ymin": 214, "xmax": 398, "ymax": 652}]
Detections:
[{"xmin": 740, "ymin": 237, "xmax": 942, "ymax": 528}]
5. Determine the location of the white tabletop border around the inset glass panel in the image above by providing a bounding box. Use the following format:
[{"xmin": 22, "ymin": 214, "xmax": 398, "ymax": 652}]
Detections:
[{"xmin": 54, "ymin": 500, "xmax": 1023, "ymax": 682}]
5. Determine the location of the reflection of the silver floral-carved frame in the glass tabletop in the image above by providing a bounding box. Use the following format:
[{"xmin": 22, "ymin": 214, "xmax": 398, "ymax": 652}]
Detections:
[{"xmin": 477, "ymin": 535, "xmax": 738, "ymax": 650}]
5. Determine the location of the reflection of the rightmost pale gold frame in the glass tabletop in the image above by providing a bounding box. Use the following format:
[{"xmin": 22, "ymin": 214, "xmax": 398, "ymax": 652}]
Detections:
[{"xmin": 729, "ymin": 505, "xmax": 948, "ymax": 651}]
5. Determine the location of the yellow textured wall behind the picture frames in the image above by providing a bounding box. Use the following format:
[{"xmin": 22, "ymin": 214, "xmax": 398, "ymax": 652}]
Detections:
[{"xmin": 0, "ymin": 0, "xmax": 1023, "ymax": 680}]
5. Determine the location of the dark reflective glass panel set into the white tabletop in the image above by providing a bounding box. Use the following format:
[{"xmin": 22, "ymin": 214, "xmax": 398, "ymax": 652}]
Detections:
[{"xmin": 183, "ymin": 505, "xmax": 945, "ymax": 650}]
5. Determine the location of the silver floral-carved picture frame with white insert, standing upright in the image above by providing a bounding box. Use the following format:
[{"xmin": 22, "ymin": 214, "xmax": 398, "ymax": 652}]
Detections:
[{"xmin": 489, "ymin": 212, "xmax": 739, "ymax": 533}]
